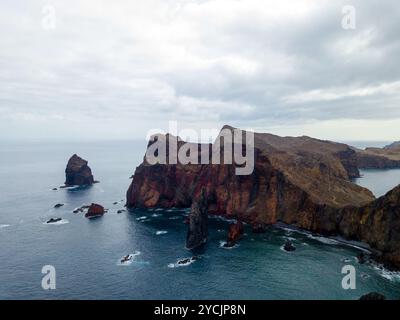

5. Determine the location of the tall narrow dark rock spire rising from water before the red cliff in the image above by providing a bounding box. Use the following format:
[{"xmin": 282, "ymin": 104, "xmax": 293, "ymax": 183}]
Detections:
[{"xmin": 186, "ymin": 188, "xmax": 208, "ymax": 249}]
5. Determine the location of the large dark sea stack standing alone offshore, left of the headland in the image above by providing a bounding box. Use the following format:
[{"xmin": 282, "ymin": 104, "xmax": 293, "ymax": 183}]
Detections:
[{"xmin": 65, "ymin": 154, "xmax": 95, "ymax": 186}]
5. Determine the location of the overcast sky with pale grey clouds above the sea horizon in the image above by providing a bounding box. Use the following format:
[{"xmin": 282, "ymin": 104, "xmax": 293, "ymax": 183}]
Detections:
[{"xmin": 0, "ymin": 0, "xmax": 400, "ymax": 141}]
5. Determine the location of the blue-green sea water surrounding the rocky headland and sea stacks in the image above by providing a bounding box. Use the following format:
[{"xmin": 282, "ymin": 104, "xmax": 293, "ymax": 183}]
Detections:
[{"xmin": 0, "ymin": 141, "xmax": 400, "ymax": 299}]
